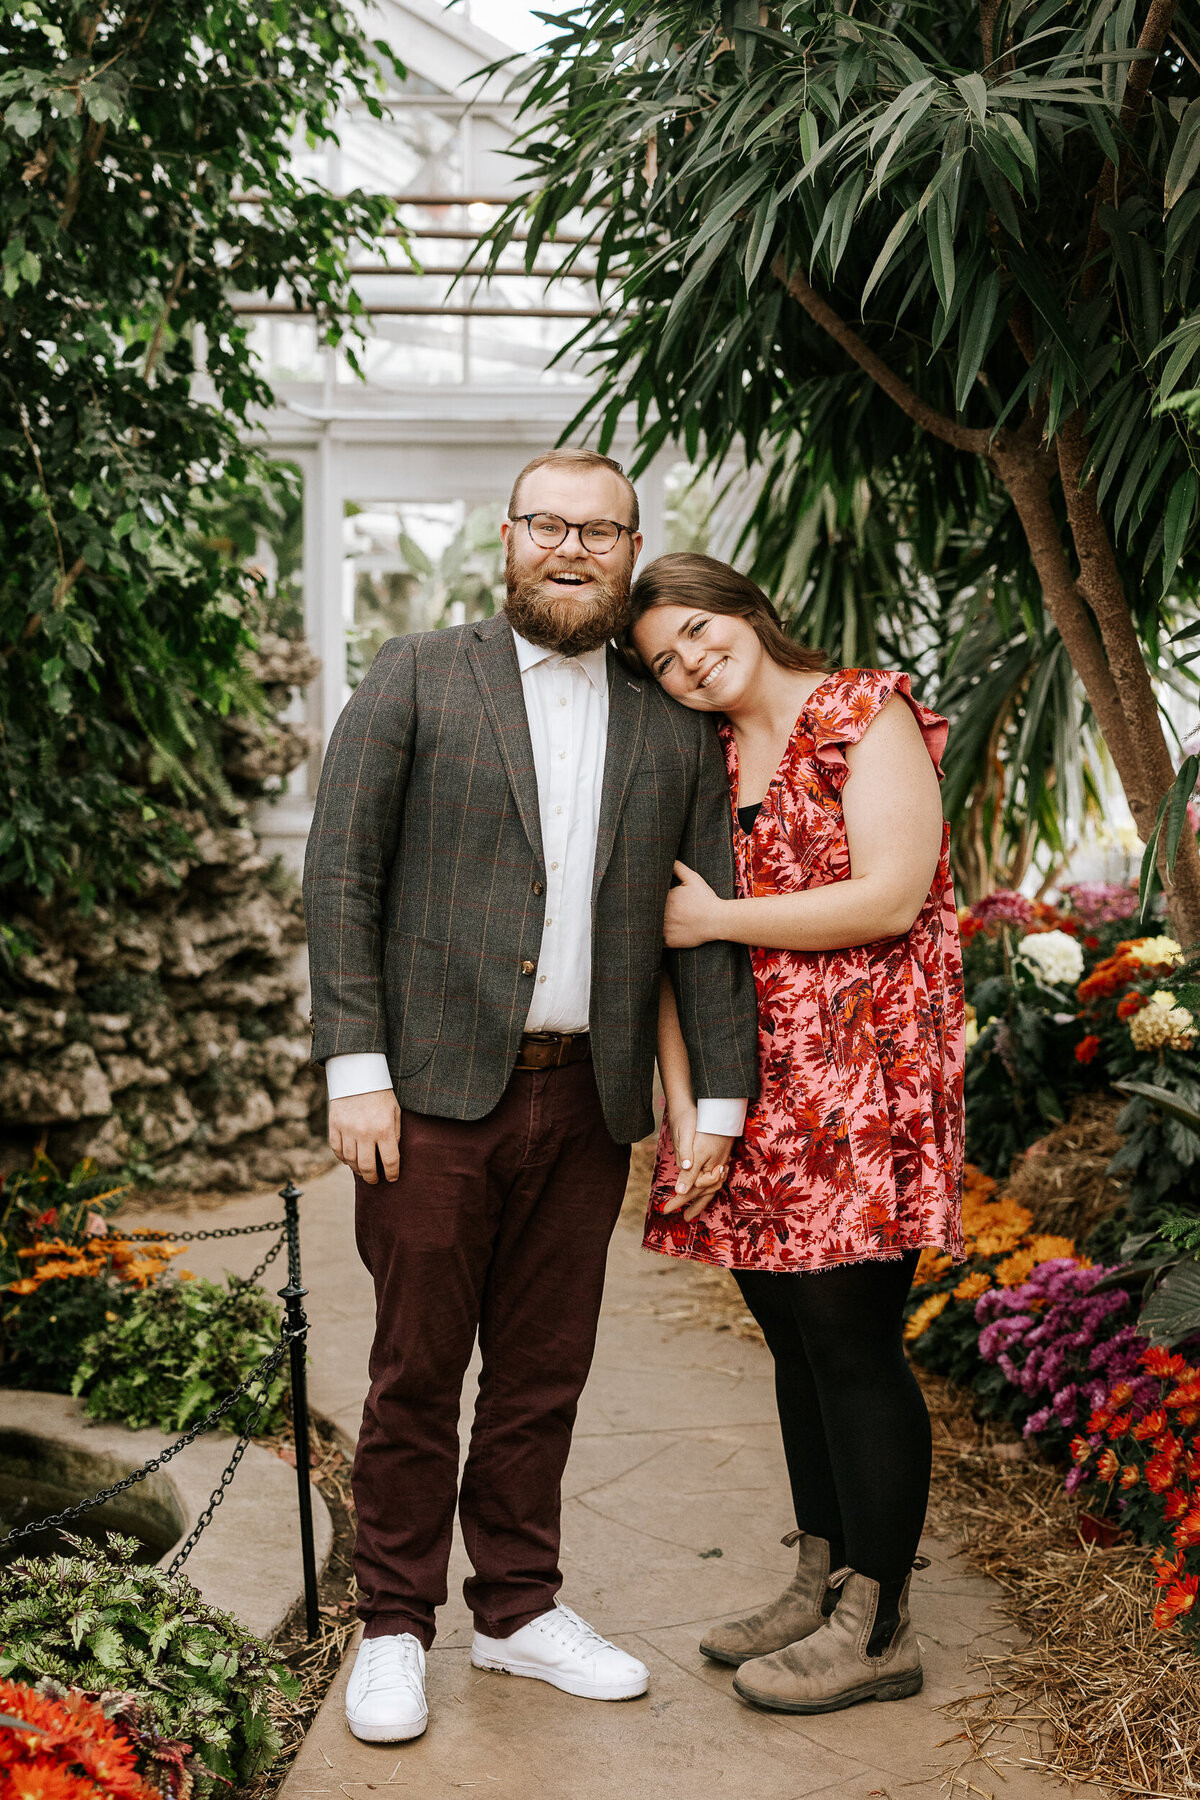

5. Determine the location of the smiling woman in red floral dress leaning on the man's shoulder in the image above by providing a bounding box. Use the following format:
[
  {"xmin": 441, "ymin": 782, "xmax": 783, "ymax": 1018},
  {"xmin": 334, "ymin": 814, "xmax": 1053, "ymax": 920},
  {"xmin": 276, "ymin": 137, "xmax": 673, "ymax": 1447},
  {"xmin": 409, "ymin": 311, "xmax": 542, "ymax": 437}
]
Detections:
[{"xmin": 630, "ymin": 554, "xmax": 964, "ymax": 1712}]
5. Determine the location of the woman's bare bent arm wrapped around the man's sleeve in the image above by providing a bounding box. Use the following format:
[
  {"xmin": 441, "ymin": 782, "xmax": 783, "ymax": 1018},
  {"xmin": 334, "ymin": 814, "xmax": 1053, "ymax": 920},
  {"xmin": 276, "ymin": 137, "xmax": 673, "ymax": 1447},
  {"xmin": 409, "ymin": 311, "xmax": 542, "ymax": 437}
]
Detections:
[{"xmin": 664, "ymin": 698, "xmax": 943, "ymax": 950}]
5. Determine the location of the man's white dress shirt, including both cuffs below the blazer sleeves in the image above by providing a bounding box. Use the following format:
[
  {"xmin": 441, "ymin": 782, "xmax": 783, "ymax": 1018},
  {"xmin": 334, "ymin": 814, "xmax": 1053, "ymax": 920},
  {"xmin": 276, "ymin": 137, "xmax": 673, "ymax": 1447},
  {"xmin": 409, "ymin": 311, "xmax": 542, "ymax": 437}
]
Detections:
[{"xmin": 326, "ymin": 632, "xmax": 747, "ymax": 1138}]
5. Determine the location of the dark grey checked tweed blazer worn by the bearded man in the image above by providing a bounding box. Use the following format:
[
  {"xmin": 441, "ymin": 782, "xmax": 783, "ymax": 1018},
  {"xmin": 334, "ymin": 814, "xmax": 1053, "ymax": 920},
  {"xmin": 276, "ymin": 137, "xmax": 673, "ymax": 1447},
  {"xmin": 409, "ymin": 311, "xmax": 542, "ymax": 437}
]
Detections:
[{"xmin": 304, "ymin": 614, "xmax": 757, "ymax": 1143}]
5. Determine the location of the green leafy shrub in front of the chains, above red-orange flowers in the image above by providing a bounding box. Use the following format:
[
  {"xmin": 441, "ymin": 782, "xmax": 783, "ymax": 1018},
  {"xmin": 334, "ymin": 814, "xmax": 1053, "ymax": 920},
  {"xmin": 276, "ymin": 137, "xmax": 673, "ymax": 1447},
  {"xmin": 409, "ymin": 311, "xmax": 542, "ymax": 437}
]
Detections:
[{"xmin": 0, "ymin": 1534, "xmax": 297, "ymax": 1800}]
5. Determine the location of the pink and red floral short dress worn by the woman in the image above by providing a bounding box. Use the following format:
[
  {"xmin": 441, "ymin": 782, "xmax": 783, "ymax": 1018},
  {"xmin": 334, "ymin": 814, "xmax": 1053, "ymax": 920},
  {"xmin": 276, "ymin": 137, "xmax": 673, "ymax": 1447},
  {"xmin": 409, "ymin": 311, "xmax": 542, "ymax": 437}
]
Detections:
[{"xmin": 644, "ymin": 670, "xmax": 964, "ymax": 1271}]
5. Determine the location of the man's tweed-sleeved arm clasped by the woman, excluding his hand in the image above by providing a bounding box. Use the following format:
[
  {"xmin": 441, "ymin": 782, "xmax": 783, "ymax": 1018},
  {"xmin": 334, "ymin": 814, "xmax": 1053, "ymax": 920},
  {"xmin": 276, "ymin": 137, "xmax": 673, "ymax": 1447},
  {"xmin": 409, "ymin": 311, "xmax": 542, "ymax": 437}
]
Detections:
[{"xmin": 664, "ymin": 718, "xmax": 759, "ymax": 1108}]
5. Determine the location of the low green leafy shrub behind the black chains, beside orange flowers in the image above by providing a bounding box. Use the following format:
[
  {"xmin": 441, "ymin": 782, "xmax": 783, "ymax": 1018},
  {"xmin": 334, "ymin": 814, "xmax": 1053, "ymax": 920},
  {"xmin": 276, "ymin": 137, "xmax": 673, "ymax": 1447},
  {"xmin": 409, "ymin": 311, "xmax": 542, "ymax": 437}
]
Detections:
[{"xmin": 70, "ymin": 1276, "xmax": 288, "ymax": 1431}]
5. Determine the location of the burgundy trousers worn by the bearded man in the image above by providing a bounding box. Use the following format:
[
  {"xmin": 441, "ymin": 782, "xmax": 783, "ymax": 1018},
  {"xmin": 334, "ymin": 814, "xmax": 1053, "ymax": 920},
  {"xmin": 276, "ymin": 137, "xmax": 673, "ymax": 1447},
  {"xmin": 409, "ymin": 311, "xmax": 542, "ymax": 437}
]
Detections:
[{"xmin": 353, "ymin": 1062, "xmax": 630, "ymax": 1649}]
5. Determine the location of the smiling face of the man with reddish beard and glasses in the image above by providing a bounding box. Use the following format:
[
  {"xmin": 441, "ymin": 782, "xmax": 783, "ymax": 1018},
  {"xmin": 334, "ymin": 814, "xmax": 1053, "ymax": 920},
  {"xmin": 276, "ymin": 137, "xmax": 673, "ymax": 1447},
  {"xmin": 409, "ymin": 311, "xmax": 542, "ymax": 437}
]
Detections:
[{"xmin": 500, "ymin": 464, "xmax": 642, "ymax": 655}]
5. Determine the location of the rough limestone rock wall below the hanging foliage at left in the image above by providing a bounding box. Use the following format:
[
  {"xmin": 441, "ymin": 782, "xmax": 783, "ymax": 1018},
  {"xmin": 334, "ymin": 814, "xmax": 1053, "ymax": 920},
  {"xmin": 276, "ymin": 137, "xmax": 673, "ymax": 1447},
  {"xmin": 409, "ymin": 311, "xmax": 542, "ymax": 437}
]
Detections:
[{"xmin": 0, "ymin": 637, "xmax": 329, "ymax": 1190}]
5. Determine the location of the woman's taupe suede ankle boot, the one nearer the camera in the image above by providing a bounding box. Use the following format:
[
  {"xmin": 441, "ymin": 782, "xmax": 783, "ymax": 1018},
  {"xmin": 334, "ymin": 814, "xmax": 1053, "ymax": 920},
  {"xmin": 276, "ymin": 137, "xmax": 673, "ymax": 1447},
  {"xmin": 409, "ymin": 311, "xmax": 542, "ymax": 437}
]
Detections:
[{"xmin": 734, "ymin": 1570, "xmax": 923, "ymax": 1712}]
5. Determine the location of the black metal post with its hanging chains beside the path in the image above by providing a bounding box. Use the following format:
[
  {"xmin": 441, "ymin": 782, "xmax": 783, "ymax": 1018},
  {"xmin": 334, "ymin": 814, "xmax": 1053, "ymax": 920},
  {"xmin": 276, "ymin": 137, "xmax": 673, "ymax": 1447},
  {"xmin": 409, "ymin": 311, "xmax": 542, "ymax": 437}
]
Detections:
[{"xmin": 0, "ymin": 1181, "xmax": 318, "ymax": 1638}]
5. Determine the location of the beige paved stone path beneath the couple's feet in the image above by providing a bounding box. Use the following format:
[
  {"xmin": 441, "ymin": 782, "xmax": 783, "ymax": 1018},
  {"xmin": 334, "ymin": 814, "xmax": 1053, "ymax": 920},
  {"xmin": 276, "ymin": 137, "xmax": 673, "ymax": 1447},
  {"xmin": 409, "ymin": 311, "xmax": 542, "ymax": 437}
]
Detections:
[{"xmin": 148, "ymin": 1170, "xmax": 1063, "ymax": 1800}]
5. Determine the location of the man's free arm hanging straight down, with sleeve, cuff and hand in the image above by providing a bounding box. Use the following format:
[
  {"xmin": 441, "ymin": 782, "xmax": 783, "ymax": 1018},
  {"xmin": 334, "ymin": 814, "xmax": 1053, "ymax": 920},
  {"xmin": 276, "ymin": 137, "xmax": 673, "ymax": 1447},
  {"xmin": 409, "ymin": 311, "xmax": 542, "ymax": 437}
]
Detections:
[{"xmin": 304, "ymin": 639, "xmax": 416, "ymax": 1183}]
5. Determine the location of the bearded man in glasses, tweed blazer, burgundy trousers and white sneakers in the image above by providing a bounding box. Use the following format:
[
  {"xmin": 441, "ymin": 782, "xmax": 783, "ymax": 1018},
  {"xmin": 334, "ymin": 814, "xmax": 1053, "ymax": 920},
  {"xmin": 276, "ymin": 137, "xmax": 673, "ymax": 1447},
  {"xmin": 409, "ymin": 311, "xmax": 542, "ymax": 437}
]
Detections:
[{"xmin": 304, "ymin": 450, "xmax": 756, "ymax": 1742}]
